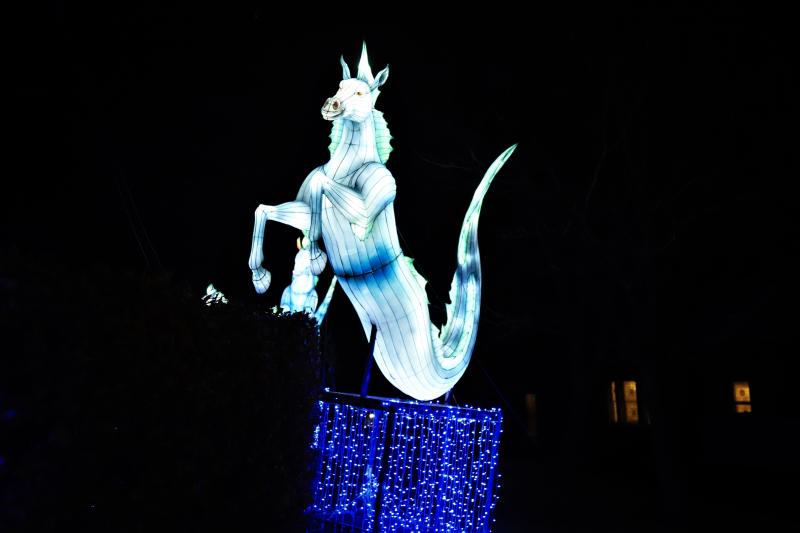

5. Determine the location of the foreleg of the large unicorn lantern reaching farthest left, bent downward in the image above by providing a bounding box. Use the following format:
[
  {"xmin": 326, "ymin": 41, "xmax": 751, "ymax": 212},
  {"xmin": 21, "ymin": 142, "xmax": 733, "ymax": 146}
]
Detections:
[{"xmin": 248, "ymin": 201, "xmax": 311, "ymax": 294}]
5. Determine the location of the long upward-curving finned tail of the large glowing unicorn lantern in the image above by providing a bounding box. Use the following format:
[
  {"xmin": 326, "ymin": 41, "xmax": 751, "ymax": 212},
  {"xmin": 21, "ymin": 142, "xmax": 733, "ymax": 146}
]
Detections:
[{"xmin": 431, "ymin": 144, "xmax": 517, "ymax": 383}]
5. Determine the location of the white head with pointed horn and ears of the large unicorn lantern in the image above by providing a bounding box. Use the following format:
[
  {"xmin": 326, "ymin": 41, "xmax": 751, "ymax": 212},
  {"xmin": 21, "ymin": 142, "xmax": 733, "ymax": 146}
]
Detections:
[{"xmin": 322, "ymin": 43, "xmax": 389, "ymax": 122}]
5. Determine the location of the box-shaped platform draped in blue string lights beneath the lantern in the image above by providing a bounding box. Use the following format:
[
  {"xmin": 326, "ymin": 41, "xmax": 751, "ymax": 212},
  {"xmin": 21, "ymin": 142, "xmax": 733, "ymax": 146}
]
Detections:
[{"xmin": 307, "ymin": 391, "xmax": 503, "ymax": 532}]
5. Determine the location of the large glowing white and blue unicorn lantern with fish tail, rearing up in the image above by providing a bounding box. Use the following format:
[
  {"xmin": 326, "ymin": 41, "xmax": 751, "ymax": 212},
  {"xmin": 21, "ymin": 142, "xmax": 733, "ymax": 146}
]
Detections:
[{"xmin": 249, "ymin": 46, "xmax": 516, "ymax": 400}]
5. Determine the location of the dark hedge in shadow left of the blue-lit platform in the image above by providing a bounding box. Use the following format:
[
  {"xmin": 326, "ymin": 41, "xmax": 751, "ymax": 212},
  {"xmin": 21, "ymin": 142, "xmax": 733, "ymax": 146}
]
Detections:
[{"xmin": 0, "ymin": 255, "xmax": 319, "ymax": 532}]
